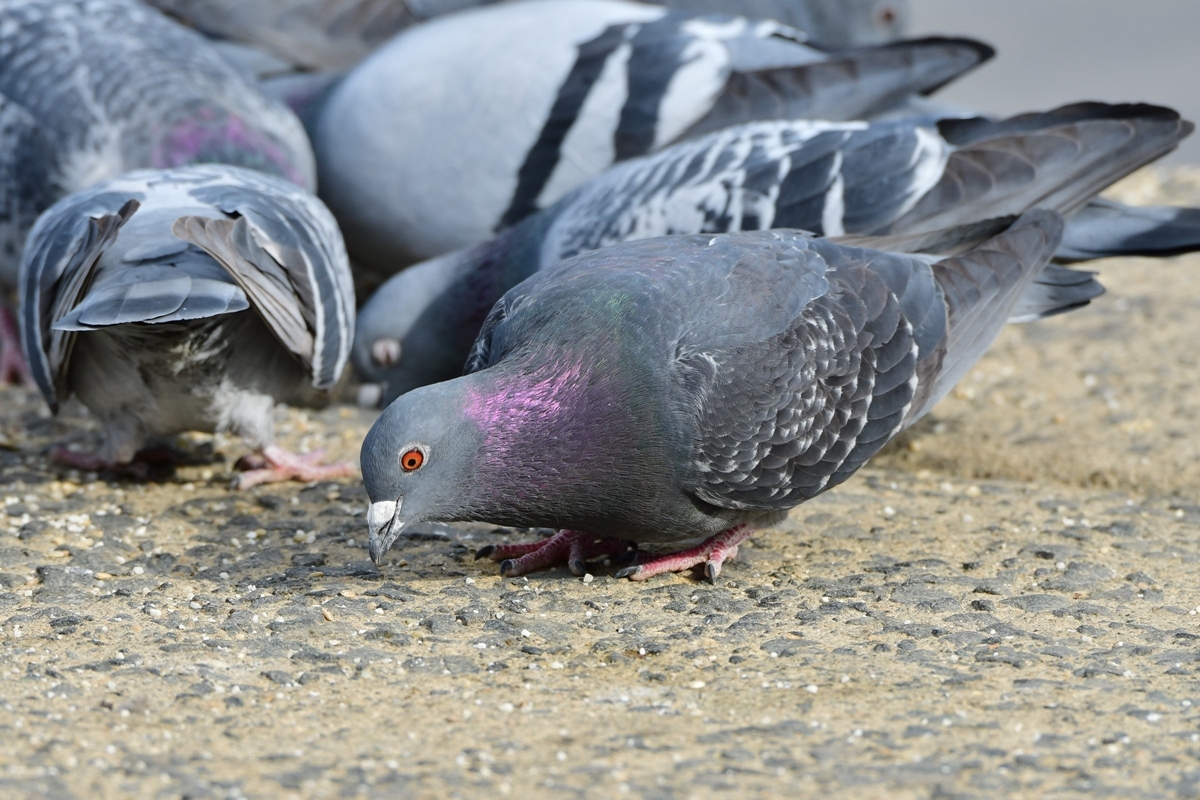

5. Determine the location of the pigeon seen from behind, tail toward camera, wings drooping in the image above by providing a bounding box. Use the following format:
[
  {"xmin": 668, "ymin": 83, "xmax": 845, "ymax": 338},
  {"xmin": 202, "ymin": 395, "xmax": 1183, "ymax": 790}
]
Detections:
[{"xmin": 20, "ymin": 164, "xmax": 354, "ymax": 488}]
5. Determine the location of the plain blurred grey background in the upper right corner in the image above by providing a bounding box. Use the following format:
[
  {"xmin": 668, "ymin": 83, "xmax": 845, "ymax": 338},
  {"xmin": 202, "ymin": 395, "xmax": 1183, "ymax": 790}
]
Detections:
[{"xmin": 908, "ymin": 0, "xmax": 1200, "ymax": 164}]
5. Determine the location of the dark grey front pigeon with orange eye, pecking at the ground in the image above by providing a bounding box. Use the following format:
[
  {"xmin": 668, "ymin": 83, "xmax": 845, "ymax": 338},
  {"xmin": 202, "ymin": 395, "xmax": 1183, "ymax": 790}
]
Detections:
[{"xmin": 361, "ymin": 211, "xmax": 1103, "ymax": 579}]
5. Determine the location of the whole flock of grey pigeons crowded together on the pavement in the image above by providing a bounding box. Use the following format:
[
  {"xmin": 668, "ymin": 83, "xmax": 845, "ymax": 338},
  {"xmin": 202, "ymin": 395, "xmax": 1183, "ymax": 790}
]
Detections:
[{"xmin": 0, "ymin": 0, "xmax": 1200, "ymax": 579}]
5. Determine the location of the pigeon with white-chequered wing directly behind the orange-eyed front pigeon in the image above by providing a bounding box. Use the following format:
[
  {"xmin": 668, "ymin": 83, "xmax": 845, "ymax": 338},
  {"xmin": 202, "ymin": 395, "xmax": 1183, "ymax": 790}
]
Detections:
[{"xmin": 353, "ymin": 103, "xmax": 1200, "ymax": 405}]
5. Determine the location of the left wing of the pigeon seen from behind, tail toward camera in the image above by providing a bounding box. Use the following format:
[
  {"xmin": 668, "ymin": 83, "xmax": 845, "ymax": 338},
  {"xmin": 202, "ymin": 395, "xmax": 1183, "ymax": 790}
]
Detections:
[{"xmin": 19, "ymin": 192, "xmax": 138, "ymax": 413}]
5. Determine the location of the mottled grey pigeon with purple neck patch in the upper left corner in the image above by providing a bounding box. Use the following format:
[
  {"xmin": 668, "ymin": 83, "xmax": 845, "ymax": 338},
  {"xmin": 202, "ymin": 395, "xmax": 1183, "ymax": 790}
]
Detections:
[{"xmin": 0, "ymin": 0, "xmax": 316, "ymax": 379}]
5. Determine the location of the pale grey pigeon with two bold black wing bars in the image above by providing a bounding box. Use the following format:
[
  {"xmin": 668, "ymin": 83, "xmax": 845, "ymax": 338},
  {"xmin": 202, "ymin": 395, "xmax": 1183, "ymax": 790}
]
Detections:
[{"xmin": 310, "ymin": 0, "xmax": 992, "ymax": 277}]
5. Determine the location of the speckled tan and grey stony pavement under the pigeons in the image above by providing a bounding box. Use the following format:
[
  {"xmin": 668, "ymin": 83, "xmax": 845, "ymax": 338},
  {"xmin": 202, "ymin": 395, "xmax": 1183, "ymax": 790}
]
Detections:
[{"xmin": 0, "ymin": 174, "xmax": 1200, "ymax": 798}]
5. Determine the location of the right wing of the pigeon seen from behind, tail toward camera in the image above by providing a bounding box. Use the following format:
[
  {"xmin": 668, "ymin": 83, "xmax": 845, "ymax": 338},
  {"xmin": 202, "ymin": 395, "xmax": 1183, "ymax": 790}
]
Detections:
[{"xmin": 173, "ymin": 168, "xmax": 354, "ymax": 389}]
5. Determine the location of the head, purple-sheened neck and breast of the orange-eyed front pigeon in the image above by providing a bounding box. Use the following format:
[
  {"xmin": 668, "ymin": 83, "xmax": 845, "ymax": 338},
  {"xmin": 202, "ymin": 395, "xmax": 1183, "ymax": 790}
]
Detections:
[{"xmin": 361, "ymin": 328, "xmax": 686, "ymax": 563}]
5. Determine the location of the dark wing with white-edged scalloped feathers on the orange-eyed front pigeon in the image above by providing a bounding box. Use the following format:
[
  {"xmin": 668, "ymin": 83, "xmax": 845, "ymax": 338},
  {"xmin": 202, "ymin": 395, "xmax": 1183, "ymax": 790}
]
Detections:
[{"xmin": 673, "ymin": 231, "xmax": 926, "ymax": 510}]
